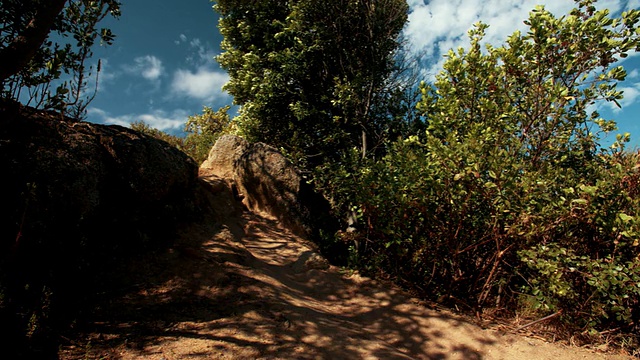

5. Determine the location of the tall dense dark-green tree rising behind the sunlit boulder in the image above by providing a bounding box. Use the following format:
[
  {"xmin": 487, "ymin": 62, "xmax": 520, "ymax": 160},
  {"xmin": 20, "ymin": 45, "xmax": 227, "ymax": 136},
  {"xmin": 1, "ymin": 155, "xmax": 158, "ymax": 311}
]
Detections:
[{"xmin": 215, "ymin": 0, "xmax": 408, "ymax": 165}]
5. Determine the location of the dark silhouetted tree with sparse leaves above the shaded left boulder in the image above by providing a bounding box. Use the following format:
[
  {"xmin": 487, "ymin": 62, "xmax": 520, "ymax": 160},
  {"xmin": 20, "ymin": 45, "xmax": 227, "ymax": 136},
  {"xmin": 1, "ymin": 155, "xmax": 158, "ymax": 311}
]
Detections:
[{"xmin": 0, "ymin": 0, "xmax": 120, "ymax": 119}]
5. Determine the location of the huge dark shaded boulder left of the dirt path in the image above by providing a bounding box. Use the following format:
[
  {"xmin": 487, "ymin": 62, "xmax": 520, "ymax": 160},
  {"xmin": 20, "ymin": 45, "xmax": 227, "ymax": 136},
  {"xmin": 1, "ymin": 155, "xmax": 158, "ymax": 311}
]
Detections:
[{"xmin": 0, "ymin": 103, "xmax": 198, "ymax": 354}]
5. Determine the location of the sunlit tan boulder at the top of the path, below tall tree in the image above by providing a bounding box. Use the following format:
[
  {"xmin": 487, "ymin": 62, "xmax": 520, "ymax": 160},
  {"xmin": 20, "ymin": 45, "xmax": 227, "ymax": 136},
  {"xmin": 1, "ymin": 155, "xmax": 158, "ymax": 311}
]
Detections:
[{"xmin": 200, "ymin": 135, "xmax": 332, "ymax": 237}]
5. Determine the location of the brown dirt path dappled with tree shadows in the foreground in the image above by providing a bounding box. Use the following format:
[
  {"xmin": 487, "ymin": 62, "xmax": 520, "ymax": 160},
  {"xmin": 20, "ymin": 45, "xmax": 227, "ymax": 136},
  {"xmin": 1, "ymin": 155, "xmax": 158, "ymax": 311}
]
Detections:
[{"xmin": 60, "ymin": 204, "xmax": 627, "ymax": 360}]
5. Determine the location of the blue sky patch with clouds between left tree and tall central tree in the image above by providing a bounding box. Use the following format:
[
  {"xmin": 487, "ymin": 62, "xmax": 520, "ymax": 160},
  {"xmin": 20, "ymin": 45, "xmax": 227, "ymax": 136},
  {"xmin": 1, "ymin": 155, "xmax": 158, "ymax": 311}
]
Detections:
[{"xmin": 88, "ymin": 0, "xmax": 232, "ymax": 133}]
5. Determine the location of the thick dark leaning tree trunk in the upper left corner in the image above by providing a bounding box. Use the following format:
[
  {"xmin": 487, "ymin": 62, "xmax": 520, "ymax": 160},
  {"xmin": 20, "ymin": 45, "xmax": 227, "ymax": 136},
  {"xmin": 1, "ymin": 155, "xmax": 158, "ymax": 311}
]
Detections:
[{"xmin": 0, "ymin": 0, "xmax": 67, "ymax": 83}]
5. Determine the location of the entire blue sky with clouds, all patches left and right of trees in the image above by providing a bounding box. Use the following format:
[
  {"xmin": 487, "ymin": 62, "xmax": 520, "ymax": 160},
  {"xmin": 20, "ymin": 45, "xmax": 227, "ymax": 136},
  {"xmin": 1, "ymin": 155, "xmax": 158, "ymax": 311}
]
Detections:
[{"xmin": 88, "ymin": 0, "xmax": 640, "ymax": 147}]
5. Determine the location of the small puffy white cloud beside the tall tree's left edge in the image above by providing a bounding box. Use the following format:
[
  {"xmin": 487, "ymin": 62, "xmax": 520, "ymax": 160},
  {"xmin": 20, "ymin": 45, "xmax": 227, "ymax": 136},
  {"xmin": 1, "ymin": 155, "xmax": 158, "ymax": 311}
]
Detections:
[{"xmin": 172, "ymin": 67, "xmax": 229, "ymax": 101}]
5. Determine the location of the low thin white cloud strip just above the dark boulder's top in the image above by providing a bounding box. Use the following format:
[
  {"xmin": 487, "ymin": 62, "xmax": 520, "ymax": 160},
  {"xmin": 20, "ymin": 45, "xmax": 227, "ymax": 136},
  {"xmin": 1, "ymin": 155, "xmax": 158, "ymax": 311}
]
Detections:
[{"xmin": 87, "ymin": 108, "xmax": 189, "ymax": 131}]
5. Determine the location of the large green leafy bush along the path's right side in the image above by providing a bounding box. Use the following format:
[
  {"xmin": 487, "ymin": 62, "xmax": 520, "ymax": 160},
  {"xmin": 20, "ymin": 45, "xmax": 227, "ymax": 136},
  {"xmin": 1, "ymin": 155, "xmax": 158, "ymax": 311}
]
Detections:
[{"xmin": 318, "ymin": 0, "xmax": 640, "ymax": 330}]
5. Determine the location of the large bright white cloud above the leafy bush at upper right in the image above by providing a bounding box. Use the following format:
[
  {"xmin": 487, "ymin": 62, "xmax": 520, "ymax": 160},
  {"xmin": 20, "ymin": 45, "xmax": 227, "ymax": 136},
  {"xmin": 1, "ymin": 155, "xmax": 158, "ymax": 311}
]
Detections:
[{"xmin": 404, "ymin": 0, "xmax": 640, "ymax": 77}]
